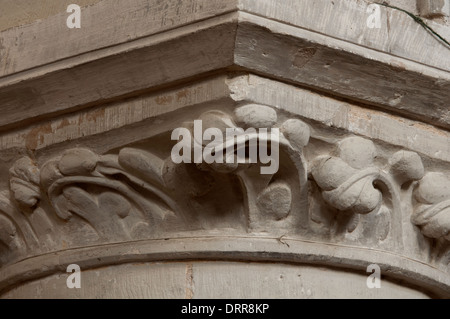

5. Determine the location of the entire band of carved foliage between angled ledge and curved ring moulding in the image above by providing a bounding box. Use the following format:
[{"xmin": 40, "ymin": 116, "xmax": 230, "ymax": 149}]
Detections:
[{"xmin": 0, "ymin": 103, "xmax": 450, "ymax": 295}]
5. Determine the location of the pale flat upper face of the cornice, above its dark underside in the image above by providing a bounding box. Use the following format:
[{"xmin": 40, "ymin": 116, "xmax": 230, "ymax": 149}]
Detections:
[{"xmin": 0, "ymin": 0, "xmax": 450, "ymax": 78}]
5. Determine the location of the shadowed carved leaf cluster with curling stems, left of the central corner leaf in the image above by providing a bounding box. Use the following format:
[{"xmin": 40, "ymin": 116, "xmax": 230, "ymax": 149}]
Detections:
[{"xmin": 41, "ymin": 148, "xmax": 176, "ymax": 240}]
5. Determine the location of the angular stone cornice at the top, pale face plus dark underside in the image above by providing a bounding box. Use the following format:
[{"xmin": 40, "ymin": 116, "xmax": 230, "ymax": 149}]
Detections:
[{"xmin": 0, "ymin": 0, "xmax": 450, "ymax": 129}]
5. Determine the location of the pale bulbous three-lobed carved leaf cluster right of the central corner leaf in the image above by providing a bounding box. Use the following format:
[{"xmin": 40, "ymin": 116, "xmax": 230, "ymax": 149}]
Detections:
[{"xmin": 312, "ymin": 137, "xmax": 424, "ymax": 238}]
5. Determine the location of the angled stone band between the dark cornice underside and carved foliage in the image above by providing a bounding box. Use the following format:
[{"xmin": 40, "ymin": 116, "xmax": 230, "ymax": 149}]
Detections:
[{"xmin": 0, "ymin": 73, "xmax": 450, "ymax": 163}]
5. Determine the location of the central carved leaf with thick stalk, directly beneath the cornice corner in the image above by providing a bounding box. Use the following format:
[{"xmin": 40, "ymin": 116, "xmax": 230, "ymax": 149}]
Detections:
[{"xmin": 185, "ymin": 104, "xmax": 310, "ymax": 232}]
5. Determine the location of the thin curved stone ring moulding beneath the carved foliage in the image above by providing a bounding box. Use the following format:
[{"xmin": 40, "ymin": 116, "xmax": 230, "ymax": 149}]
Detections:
[{"xmin": 0, "ymin": 236, "xmax": 450, "ymax": 298}]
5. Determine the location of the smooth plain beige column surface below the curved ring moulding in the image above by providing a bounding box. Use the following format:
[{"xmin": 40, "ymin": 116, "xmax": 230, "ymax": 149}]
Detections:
[{"xmin": 1, "ymin": 262, "xmax": 430, "ymax": 300}]
